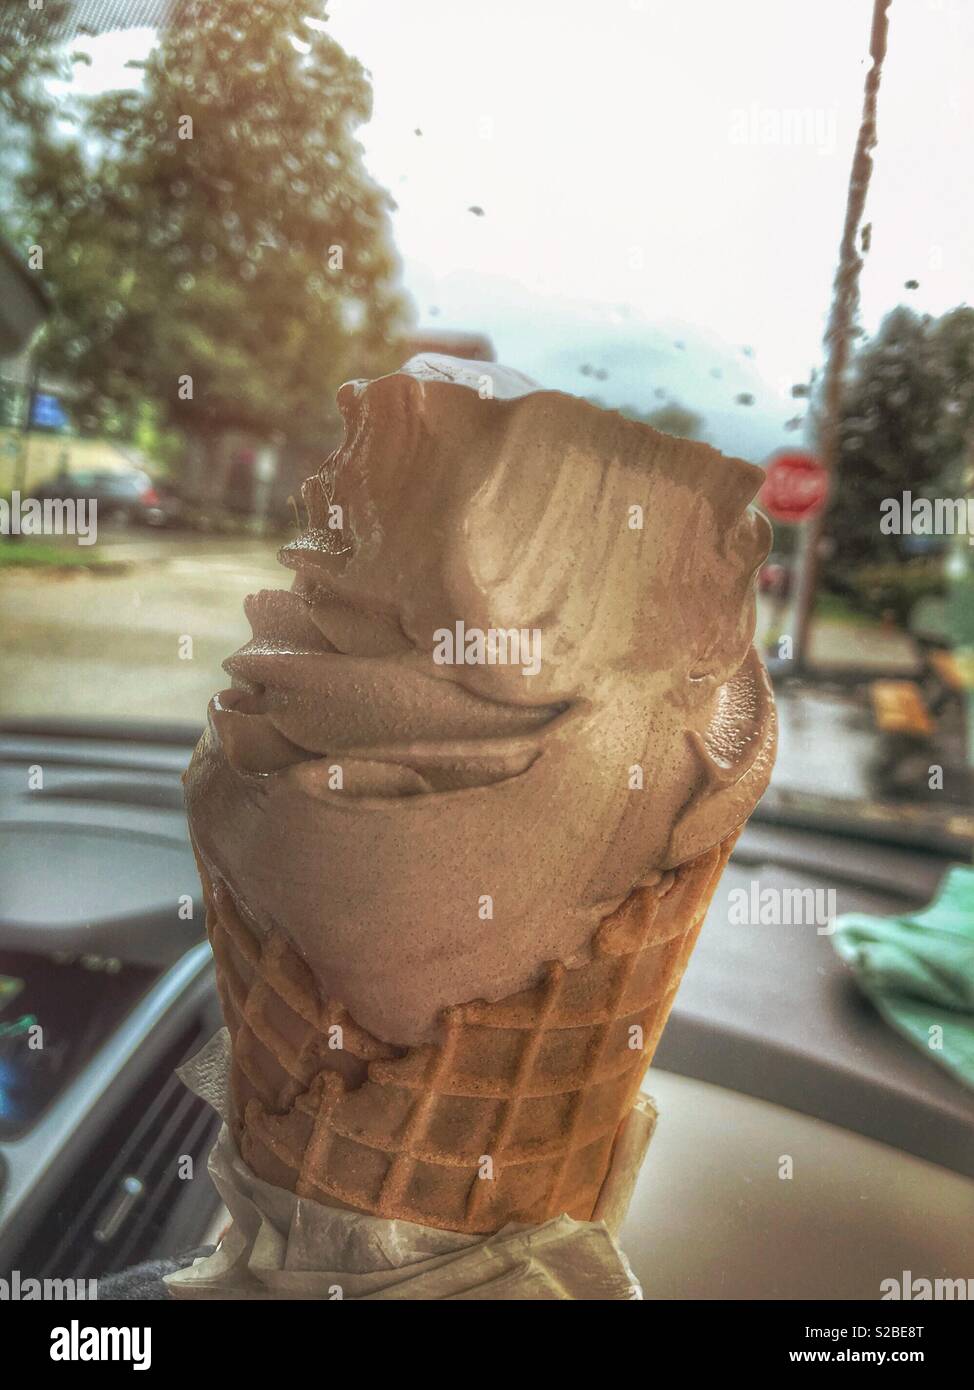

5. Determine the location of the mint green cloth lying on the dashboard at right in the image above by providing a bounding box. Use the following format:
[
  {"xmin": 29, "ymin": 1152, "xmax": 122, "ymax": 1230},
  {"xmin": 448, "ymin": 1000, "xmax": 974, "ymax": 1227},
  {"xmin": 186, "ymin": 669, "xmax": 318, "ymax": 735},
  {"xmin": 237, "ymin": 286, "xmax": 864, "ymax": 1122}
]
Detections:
[{"xmin": 832, "ymin": 865, "xmax": 974, "ymax": 1087}]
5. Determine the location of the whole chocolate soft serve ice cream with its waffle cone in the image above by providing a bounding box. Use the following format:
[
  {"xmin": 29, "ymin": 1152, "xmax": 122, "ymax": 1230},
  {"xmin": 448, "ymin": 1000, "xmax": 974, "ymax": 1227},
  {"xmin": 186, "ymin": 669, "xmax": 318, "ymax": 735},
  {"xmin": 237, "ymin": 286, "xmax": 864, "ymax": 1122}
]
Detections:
[{"xmin": 186, "ymin": 356, "xmax": 775, "ymax": 1234}]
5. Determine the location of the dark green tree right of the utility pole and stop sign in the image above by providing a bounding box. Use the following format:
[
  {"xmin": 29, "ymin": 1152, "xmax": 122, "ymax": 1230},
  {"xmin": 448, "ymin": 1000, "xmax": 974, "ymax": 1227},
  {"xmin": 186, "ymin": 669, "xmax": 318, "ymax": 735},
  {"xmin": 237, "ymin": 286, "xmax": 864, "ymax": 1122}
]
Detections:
[{"xmin": 825, "ymin": 306, "xmax": 974, "ymax": 587}]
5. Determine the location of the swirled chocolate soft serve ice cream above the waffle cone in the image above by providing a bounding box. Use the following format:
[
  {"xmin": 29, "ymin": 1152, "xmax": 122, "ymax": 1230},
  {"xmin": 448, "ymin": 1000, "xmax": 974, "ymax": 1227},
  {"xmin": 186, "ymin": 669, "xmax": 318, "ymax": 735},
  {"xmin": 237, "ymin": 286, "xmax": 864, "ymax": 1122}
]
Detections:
[{"xmin": 186, "ymin": 356, "xmax": 775, "ymax": 1048}]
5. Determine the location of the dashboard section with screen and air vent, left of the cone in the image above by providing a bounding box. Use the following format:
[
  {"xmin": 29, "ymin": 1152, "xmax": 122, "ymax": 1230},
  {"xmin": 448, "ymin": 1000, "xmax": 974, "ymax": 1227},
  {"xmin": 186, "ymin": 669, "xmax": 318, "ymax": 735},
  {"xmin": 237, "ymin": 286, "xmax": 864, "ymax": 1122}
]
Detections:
[{"xmin": 0, "ymin": 734, "xmax": 221, "ymax": 1279}]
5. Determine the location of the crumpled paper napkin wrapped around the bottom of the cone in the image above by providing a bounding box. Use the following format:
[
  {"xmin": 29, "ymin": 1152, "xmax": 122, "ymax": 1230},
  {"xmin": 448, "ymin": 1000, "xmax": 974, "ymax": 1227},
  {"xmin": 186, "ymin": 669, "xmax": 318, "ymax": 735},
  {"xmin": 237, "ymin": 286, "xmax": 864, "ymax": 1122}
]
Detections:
[{"xmin": 165, "ymin": 1029, "xmax": 656, "ymax": 1301}]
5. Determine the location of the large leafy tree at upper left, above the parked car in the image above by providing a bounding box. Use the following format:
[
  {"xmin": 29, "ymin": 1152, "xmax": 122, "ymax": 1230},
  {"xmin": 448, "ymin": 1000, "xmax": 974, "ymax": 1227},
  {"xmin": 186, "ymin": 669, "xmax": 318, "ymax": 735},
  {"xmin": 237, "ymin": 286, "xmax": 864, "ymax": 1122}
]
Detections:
[{"xmin": 7, "ymin": 0, "xmax": 406, "ymax": 472}]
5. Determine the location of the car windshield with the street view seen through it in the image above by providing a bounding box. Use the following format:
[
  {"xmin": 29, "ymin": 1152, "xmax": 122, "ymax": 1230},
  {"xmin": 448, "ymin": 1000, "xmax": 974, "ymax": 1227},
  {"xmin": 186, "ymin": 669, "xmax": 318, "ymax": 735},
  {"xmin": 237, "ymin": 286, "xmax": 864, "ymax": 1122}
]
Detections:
[{"xmin": 0, "ymin": 0, "xmax": 974, "ymax": 848}]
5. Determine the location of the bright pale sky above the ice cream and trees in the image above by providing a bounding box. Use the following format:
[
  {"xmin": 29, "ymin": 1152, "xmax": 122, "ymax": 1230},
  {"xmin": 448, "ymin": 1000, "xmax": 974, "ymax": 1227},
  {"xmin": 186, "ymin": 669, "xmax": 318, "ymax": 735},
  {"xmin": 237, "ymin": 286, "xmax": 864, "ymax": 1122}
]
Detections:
[{"xmin": 64, "ymin": 0, "xmax": 974, "ymax": 457}]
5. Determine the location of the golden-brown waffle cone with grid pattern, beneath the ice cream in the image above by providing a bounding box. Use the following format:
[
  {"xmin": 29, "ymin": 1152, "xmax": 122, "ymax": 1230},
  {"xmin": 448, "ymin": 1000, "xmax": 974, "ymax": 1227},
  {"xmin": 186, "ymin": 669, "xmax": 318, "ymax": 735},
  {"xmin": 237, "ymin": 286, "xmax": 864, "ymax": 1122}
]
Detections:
[{"xmin": 200, "ymin": 835, "xmax": 736, "ymax": 1233}]
